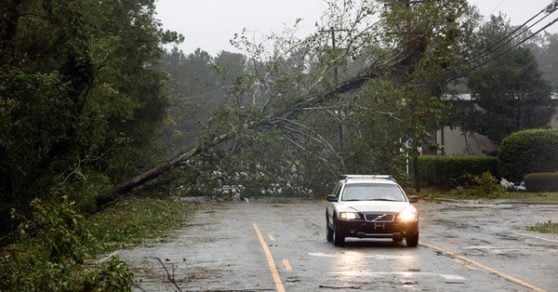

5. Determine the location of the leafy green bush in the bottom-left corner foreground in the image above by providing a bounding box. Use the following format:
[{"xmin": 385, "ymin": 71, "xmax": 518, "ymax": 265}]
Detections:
[{"xmin": 0, "ymin": 197, "xmax": 133, "ymax": 291}]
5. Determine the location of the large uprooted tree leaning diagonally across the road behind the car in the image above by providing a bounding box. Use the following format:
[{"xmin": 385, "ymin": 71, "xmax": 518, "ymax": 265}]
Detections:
[{"xmin": 105, "ymin": 0, "xmax": 478, "ymax": 199}]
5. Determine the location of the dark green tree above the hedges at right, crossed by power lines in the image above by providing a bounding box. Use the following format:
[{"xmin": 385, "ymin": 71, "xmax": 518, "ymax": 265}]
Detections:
[{"xmin": 458, "ymin": 16, "xmax": 554, "ymax": 144}]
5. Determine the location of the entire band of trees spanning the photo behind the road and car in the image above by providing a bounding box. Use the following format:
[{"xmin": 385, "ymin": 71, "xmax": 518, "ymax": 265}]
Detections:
[{"xmin": 0, "ymin": 0, "xmax": 555, "ymax": 228}]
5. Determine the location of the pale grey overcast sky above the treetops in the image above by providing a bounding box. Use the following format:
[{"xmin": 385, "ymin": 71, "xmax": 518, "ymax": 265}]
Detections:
[{"xmin": 157, "ymin": 0, "xmax": 558, "ymax": 55}]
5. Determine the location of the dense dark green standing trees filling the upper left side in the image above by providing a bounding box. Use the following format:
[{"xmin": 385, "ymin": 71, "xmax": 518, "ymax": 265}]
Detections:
[{"xmin": 0, "ymin": 0, "xmax": 181, "ymax": 231}]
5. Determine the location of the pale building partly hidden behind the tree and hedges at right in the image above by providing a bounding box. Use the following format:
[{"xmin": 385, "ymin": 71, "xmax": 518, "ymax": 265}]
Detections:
[{"xmin": 432, "ymin": 93, "xmax": 558, "ymax": 156}]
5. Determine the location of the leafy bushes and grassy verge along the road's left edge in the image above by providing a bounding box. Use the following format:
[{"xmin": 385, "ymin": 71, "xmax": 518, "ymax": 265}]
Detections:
[{"xmin": 0, "ymin": 193, "xmax": 194, "ymax": 291}]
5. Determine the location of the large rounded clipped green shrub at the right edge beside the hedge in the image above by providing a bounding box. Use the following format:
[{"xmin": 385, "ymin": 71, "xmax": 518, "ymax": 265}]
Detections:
[{"xmin": 498, "ymin": 129, "xmax": 558, "ymax": 182}]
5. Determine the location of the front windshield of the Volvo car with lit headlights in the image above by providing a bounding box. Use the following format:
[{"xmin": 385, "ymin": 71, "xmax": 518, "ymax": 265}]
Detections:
[{"xmin": 342, "ymin": 183, "xmax": 406, "ymax": 201}]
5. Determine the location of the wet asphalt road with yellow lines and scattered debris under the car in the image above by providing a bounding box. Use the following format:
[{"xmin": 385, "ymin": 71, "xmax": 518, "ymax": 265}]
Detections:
[{"xmin": 118, "ymin": 201, "xmax": 558, "ymax": 291}]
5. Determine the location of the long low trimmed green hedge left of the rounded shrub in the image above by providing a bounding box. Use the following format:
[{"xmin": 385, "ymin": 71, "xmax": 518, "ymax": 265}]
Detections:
[{"xmin": 419, "ymin": 155, "xmax": 498, "ymax": 188}]
